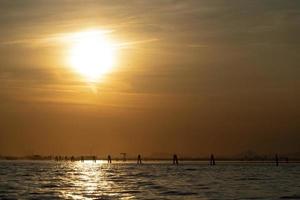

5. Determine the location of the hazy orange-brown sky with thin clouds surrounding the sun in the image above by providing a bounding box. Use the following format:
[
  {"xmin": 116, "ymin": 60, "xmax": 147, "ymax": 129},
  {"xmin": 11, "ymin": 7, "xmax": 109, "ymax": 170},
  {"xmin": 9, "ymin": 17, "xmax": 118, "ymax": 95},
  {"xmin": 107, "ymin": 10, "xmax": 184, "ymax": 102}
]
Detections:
[{"xmin": 0, "ymin": 0, "xmax": 300, "ymax": 156}]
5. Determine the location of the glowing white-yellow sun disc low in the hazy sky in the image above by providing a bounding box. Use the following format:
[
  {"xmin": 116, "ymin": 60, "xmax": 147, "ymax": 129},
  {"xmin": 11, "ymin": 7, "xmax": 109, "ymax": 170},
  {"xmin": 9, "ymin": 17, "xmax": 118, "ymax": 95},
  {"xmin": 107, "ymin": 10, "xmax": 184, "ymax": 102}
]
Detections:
[{"xmin": 68, "ymin": 30, "xmax": 115, "ymax": 81}]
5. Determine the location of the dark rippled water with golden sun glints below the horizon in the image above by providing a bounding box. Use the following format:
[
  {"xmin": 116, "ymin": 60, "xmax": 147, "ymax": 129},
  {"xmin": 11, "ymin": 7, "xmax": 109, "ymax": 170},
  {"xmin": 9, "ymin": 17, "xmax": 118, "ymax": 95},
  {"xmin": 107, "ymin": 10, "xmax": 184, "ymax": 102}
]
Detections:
[{"xmin": 0, "ymin": 161, "xmax": 300, "ymax": 199}]
